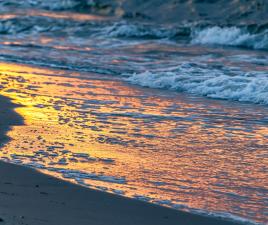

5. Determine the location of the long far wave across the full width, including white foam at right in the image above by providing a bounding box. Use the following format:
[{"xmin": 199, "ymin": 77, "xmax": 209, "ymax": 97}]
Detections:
[{"xmin": 0, "ymin": 15, "xmax": 268, "ymax": 50}]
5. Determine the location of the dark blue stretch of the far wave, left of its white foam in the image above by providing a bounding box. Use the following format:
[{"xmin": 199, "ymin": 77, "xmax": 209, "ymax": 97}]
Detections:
[{"xmin": 0, "ymin": 15, "xmax": 190, "ymax": 39}]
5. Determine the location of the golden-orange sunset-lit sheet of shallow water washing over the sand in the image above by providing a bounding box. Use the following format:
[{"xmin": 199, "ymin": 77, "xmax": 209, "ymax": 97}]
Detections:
[{"xmin": 0, "ymin": 63, "xmax": 268, "ymax": 220}]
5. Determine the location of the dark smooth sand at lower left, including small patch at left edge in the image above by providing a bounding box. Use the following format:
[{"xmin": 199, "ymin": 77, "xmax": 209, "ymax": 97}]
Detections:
[{"xmin": 0, "ymin": 97, "xmax": 243, "ymax": 225}]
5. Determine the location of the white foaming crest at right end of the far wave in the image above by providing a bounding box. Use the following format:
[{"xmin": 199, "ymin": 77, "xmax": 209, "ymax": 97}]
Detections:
[{"xmin": 191, "ymin": 26, "xmax": 268, "ymax": 49}]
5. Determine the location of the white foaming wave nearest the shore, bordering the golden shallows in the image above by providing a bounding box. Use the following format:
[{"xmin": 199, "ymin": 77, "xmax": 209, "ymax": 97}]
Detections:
[{"xmin": 126, "ymin": 63, "xmax": 268, "ymax": 105}]
